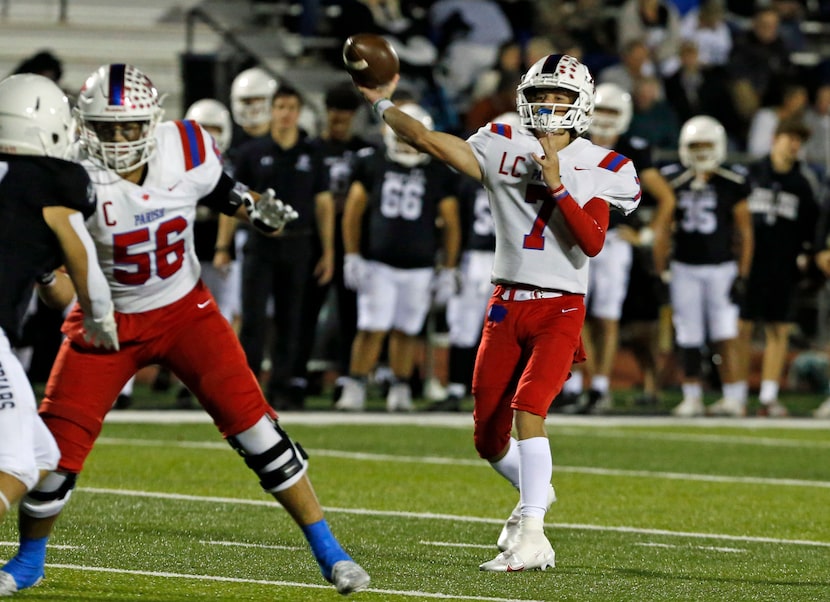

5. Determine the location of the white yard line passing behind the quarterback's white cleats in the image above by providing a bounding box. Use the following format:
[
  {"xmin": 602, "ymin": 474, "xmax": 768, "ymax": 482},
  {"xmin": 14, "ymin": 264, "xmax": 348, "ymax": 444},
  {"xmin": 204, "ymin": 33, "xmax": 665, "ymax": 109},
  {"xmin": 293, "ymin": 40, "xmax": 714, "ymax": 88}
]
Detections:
[{"xmin": 78, "ymin": 487, "xmax": 830, "ymax": 548}]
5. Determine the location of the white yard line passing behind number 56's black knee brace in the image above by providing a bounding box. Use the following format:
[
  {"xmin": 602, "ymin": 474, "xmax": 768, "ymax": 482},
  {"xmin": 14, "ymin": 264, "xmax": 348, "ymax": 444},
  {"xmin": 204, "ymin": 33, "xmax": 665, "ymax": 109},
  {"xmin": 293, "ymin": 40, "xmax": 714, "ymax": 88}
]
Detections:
[{"xmin": 98, "ymin": 437, "xmax": 830, "ymax": 489}]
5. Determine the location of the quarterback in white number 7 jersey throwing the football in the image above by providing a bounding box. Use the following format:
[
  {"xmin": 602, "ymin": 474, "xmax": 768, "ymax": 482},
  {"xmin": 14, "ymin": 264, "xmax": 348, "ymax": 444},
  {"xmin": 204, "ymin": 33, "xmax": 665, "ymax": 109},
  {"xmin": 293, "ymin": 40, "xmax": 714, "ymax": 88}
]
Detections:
[{"xmin": 358, "ymin": 55, "xmax": 640, "ymax": 571}]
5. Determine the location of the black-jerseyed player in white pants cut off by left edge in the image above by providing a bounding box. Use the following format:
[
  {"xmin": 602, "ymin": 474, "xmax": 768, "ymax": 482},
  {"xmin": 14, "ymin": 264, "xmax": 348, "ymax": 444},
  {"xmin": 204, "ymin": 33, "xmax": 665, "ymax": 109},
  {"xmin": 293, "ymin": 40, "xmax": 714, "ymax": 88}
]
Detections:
[{"xmin": 0, "ymin": 74, "xmax": 118, "ymax": 548}]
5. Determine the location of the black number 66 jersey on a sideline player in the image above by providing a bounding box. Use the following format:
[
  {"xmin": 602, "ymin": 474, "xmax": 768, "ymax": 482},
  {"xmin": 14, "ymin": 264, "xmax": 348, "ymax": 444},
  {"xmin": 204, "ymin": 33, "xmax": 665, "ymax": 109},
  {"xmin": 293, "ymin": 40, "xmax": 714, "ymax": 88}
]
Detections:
[{"xmin": 353, "ymin": 145, "xmax": 458, "ymax": 269}]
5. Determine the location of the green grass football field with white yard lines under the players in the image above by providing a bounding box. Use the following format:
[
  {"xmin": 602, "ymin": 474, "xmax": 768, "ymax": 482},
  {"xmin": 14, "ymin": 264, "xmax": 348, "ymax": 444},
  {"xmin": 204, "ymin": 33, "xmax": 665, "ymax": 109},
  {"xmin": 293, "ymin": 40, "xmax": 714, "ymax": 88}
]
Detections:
[{"xmin": 0, "ymin": 386, "xmax": 830, "ymax": 602}]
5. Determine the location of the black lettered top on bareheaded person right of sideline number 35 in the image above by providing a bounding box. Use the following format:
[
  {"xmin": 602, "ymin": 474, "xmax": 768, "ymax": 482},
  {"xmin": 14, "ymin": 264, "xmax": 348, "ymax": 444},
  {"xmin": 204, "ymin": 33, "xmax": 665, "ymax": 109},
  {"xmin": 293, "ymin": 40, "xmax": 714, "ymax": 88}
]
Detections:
[{"xmin": 748, "ymin": 157, "xmax": 819, "ymax": 281}]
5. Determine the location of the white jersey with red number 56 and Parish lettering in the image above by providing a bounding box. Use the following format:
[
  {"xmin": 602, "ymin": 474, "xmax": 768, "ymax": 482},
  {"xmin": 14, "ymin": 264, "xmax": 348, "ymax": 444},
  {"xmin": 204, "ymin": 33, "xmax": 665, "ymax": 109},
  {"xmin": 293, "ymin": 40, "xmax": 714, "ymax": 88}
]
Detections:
[{"xmin": 82, "ymin": 121, "xmax": 222, "ymax": 313}]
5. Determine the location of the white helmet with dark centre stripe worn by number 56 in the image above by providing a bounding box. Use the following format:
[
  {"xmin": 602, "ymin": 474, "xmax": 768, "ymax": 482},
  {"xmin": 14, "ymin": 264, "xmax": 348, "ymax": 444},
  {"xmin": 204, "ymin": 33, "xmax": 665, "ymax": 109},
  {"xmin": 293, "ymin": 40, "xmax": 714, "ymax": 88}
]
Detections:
[{"xmin": 76, "ymin": 63, "xmax": 164, "ymax": 173}]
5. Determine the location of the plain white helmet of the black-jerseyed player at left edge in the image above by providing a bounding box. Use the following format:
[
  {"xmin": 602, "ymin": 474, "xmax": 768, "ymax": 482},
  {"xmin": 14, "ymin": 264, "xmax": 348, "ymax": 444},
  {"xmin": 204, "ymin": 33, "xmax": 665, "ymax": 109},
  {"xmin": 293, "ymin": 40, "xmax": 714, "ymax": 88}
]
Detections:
[{"xmin": 0, "ymin": 73, "xmax": 75, "ymax": 157}]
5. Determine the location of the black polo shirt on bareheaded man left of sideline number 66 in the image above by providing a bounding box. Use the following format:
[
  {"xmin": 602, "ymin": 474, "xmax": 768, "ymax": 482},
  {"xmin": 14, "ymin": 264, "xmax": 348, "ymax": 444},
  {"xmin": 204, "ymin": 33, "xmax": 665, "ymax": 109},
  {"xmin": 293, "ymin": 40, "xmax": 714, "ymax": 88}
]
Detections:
[{"xmin": 235, "ymin": 136, "xmax": 329, "ymax": 240}]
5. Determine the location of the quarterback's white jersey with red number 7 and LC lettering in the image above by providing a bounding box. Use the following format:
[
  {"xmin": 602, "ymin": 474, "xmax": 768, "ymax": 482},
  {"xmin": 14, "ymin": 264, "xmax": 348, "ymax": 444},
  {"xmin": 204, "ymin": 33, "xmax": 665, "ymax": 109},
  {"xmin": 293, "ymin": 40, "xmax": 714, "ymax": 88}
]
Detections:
[{"xmin": 467, "ymin": 123, "xmax": 640, "ymax": 294}]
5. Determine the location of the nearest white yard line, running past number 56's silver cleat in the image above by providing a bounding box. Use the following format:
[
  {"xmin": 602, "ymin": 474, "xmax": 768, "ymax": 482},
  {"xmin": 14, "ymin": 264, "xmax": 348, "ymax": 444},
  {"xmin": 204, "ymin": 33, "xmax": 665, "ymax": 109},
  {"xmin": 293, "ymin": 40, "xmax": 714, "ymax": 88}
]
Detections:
[{"xmin": 39, "ymin": 563, "xmax": 543, "ymax": 602}]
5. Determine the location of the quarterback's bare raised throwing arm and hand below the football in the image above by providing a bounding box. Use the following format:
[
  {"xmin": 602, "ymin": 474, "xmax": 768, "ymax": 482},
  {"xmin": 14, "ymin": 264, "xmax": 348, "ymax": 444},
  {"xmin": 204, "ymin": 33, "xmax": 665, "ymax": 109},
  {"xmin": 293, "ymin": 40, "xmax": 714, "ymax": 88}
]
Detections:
[{"xmin": 355, "ymin": 75, "xmax": 482, "ymax": 182}]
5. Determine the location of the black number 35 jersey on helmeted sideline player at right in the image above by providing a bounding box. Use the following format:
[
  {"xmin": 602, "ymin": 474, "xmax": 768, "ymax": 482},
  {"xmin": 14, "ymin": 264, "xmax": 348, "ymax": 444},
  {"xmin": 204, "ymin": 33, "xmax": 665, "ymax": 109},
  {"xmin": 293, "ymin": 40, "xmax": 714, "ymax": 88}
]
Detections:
[{"xmin": 661, "ymin": 164, "xmax": 749, "ymax": 265}]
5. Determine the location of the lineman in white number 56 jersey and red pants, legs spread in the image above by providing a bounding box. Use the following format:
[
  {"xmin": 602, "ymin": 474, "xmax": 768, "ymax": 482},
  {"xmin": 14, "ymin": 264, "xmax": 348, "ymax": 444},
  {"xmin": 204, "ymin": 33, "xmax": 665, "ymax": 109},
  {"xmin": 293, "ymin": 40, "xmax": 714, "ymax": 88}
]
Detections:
[{"xmin": 0, "ymin": 64, "xmax": 369, "ymax": 595}]
